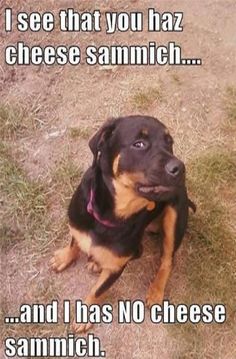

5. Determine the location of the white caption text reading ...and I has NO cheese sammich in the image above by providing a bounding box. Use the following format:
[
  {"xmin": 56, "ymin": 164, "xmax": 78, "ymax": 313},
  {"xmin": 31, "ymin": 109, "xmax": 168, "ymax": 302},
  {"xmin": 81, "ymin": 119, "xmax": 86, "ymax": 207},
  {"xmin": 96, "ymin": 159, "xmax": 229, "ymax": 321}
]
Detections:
[{"xmin": 5, "ymin": 300, "xmax": 226, "ymax": 358}]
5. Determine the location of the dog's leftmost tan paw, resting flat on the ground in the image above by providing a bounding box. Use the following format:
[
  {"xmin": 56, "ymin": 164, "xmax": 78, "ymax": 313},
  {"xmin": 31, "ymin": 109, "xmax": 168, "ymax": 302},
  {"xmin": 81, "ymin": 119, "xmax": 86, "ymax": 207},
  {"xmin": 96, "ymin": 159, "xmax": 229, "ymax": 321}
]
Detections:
[{"xmin": 50, "ymin": 246, "xmax": 78, "ymax": 272}]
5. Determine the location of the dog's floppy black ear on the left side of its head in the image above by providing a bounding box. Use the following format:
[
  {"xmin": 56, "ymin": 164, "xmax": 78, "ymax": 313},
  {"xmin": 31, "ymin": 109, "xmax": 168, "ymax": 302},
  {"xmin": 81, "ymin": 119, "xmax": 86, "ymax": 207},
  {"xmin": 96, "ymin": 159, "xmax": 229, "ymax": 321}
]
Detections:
[{"xmin": 89, "ymin": 118, "xmax": 117, "ymax": 161}]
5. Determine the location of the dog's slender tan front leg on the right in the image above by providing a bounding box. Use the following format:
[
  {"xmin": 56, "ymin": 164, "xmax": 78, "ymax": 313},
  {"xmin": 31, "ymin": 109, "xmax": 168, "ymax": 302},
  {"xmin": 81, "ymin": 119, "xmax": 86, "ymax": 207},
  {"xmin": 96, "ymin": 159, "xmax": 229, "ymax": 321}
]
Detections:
[{"xmin": 147, "ymin": 206, "xmax": 177, "ymax": 306}]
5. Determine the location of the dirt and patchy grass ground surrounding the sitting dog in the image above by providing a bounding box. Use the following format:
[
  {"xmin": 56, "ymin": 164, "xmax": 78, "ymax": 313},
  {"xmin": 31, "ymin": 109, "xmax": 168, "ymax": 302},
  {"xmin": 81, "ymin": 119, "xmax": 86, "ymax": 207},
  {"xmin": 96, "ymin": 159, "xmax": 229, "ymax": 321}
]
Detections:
[{"xmin": 0, "ymin": 0, "xmax": 236, "ymax": 359}]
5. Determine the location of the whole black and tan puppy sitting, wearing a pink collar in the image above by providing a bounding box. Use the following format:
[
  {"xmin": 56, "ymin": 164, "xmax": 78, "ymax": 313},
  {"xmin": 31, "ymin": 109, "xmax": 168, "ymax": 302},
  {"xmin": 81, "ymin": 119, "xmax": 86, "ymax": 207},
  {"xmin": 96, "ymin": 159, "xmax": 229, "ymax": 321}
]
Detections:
[{"xmin": 51, "ymin": 116, "xmax": 194, "ymax": 331}]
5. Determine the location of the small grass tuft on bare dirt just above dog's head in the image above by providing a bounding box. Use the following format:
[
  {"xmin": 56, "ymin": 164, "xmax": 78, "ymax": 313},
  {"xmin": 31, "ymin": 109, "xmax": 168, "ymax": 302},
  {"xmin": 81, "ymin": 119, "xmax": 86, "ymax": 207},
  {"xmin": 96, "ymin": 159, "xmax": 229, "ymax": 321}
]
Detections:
[{"xmin": 131, "ymin": 87, "xmax": 162, "ymax": 110}]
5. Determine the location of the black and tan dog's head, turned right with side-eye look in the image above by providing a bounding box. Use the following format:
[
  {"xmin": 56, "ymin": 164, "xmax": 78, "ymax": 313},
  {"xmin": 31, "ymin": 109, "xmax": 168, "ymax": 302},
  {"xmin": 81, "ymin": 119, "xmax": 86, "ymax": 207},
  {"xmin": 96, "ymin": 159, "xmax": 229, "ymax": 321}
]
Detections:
[{"xmin": 89, "ymin": 116, "xmax": 185, "ymax": 217}]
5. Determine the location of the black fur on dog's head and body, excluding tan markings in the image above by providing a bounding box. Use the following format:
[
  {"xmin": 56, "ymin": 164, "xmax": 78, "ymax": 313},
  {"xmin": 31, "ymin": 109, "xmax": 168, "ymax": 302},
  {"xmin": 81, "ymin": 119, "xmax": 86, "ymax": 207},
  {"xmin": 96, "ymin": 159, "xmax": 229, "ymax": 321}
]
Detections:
[{"xmin": 68, "ymin": 116, "xmax": 194, "ymax": 258}]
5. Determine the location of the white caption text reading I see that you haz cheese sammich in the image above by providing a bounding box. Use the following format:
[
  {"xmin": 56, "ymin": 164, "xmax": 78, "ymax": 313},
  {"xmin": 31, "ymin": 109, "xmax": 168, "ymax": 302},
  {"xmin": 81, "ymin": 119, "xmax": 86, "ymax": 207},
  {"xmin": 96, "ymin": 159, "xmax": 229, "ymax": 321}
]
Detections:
[{"xmin": 5, "ymin": 8, "xmax": 202, "ymax": 66}]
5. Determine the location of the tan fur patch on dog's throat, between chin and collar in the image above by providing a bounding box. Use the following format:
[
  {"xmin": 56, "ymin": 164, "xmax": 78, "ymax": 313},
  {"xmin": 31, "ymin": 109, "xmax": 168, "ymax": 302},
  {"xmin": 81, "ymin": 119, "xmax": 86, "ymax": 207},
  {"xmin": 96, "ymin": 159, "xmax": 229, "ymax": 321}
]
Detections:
[{"xmin": 113, "ymin": 173, "xmax": 155, "ymax": 218}]
